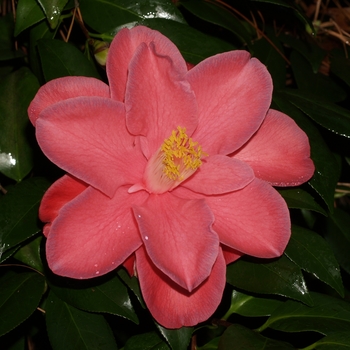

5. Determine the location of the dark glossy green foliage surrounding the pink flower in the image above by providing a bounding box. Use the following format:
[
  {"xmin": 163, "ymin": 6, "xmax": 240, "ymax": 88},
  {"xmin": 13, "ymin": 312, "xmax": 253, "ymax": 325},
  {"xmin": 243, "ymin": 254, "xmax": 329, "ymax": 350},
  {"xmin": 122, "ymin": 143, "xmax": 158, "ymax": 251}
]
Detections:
[{"xmin": 0, "ymin": 0, "xmax": 350, "ymax": 350}]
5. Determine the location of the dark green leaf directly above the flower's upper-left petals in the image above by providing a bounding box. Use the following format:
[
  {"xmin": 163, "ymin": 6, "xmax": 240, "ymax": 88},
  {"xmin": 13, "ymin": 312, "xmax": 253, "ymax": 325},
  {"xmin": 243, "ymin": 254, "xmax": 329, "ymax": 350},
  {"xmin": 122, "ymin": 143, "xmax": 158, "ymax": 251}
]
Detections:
[{"xmin": 38, "ymin": 39, "xmax": 99, "ymax": 81}]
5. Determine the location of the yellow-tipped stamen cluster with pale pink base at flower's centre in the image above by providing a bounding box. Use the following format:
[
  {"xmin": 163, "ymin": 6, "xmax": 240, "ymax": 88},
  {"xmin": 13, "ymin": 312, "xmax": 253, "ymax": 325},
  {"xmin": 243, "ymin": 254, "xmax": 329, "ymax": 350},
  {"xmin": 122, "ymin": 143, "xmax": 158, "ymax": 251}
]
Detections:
[{"xmin": 144, "ymin": 126, "xmax": 207, "ymax": 193}]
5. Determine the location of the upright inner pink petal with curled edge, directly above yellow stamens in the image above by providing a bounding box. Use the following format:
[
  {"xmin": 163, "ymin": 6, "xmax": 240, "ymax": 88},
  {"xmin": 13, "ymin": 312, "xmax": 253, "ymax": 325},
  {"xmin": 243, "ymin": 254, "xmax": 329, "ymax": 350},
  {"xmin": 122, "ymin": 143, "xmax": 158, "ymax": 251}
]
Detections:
[{"xmin": 125, "ymin": 43, "xmax": 198, "ymax": 154}]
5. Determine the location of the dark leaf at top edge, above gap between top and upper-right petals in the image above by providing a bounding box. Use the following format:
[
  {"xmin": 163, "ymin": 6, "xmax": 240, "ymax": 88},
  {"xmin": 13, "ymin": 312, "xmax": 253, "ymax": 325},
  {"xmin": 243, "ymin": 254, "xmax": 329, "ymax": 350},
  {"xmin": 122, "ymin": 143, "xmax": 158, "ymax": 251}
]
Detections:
[{"xmin": 180, "ymin": 0, "xmax": 252, "ymax": 45}]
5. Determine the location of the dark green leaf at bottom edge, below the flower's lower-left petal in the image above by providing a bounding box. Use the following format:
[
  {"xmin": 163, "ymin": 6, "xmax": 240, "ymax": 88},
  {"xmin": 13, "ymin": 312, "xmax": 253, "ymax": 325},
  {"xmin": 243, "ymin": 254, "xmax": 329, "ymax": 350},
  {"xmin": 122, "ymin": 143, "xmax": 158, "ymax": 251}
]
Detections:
[{"xmin": 46, "ymin": 291, "xmax": 117, "ymax": 350}]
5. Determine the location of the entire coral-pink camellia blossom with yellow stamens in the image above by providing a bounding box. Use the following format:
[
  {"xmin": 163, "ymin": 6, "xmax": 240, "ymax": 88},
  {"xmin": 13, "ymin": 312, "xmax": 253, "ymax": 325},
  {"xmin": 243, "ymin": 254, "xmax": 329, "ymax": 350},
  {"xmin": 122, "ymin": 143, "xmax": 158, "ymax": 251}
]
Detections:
[{"xmin": 28, "ymin": 26, "xmax": 314, "ymax": 328}]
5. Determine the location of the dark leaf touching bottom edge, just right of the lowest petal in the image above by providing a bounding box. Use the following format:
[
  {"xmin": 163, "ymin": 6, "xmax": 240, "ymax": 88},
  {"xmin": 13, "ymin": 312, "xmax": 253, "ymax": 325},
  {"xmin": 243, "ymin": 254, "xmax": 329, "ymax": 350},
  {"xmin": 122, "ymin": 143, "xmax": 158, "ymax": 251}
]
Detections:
[{"xmin": 218, "ymin": 324, "xmax": 295, "ymax": 350}]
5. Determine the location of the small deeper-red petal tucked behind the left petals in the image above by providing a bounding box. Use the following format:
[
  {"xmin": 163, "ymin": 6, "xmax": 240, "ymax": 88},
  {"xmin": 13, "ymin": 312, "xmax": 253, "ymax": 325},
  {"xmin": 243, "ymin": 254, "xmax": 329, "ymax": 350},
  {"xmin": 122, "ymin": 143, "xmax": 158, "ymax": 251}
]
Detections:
[{"xmin": 39, "ymin": 175, "xmax": 88, "ymax": 237}]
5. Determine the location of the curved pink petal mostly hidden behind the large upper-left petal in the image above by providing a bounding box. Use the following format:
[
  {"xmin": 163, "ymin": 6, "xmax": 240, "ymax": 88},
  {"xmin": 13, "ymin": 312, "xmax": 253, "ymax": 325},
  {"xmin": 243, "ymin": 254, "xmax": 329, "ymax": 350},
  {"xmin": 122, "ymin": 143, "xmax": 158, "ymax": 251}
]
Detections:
[{"xmin": 28, "ymin": 77, "xmax": 109, "ymax": 125}]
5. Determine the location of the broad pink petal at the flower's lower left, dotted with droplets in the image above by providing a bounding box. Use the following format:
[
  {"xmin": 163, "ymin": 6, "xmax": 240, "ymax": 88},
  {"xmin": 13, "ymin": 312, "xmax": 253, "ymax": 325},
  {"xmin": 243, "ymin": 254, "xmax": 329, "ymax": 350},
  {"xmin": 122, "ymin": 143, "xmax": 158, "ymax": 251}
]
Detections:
[{"xmin": 46, "ymin": 187, "xmax": 148, "ymax": 279}]
